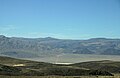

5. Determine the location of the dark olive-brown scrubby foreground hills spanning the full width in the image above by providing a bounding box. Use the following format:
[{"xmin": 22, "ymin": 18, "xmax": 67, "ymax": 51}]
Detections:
[{"xmin": 0, "ymin": 56, "xmax": 120, "ymax": 76}]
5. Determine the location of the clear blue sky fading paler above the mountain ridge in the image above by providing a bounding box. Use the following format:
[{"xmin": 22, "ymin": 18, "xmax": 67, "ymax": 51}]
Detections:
[{"xmin": 0, "ymin": 0, "xmax": 120, "ymax": 39}]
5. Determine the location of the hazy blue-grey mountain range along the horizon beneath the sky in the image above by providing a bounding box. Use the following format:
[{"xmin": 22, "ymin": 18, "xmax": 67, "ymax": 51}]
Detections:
[{"xmin": 0, "ymin": 35, "xmax": 120, "ymax": 58}]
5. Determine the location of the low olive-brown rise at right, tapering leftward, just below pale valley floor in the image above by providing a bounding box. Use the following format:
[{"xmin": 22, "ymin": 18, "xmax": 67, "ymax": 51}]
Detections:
[{"xmin": 72, "ymin": 60, "xmax": 120, "ymax": 73}]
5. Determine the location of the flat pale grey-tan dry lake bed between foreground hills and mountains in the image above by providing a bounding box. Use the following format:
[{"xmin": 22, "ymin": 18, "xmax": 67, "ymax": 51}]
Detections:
[{"xmin": 23, "ymin": 54, "xmax": 120, "ymax": 64}]
